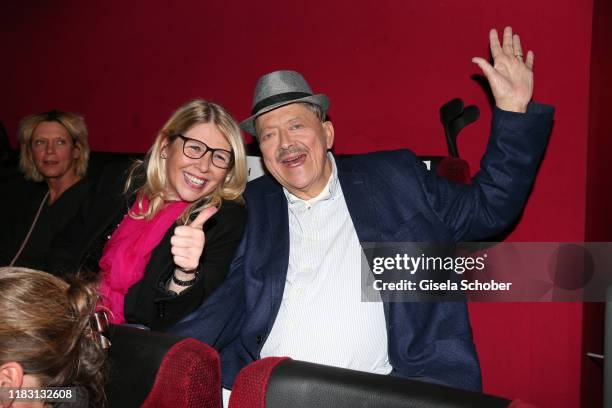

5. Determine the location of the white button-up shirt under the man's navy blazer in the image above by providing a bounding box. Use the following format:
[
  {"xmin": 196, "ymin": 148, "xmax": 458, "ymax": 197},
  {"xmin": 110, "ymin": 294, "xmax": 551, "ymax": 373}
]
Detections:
[{"xmin": 261, "ymin": 153, "xmax": 392, "ymax": 374}]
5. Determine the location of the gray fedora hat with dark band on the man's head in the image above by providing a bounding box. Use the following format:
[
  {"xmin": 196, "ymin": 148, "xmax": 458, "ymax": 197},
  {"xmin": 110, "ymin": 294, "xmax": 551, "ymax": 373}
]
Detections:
[{"xmin": 240, "ymin": 71, "xmax": 329, "ymax": 136}]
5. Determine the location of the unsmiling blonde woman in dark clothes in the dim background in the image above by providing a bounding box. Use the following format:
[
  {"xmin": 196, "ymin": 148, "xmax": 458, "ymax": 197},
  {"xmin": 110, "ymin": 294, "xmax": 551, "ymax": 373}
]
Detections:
[{"xmin": 0, "ymin": 110, "xmax": 90, "ymax": 268}]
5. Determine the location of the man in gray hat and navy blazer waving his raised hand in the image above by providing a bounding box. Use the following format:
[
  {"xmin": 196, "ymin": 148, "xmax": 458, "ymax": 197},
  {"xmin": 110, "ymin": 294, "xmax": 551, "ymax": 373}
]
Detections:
[{"xmin": 175, "ymin": 27, "xmax": 553, "ymax": 400}]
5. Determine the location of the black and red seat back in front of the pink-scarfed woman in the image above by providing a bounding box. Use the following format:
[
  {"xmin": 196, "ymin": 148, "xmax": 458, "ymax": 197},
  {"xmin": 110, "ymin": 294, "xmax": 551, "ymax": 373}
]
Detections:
[{"xmin": 106, "ymin": 325, "xmax": 221, "ymax": 408}]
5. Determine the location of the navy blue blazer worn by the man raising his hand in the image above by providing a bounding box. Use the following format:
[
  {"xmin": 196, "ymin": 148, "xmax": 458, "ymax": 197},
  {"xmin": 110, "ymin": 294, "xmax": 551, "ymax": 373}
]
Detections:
[{"xmin": 172, "ymin": 104, "xmax": 553, "ymax": 391}]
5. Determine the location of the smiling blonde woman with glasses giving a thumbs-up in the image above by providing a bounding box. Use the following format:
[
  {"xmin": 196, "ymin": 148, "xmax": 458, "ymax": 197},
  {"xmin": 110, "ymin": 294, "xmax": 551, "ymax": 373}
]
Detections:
[{"xmin": 99, "ymin": 99, "xmax": 246, "ymax": 330}]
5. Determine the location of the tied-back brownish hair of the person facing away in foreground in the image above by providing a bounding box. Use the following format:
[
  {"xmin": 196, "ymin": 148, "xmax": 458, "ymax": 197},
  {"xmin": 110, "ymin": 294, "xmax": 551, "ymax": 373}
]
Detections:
[{"xmin": 0, "ymin": 267, "xmax": 106, "ymax": 406}]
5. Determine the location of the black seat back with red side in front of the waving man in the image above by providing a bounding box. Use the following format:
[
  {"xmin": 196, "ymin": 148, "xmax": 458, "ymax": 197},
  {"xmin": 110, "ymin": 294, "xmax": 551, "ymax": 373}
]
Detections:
[{"xmin": 229, "ymin": 357, "xmax": 530, "ymax": 408}]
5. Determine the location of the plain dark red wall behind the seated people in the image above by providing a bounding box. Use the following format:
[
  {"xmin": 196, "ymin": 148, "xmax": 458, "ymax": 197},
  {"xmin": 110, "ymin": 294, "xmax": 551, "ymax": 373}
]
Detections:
[{"xmin": 0, "ymin": 0, "xmax": 609, "ymax": 407}]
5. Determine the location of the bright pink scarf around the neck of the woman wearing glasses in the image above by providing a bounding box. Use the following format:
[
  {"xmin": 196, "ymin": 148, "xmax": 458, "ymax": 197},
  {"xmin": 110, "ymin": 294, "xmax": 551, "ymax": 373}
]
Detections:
[{"xmin": 100, "ymin": 197, "xmax": 189, "ymax": 324}]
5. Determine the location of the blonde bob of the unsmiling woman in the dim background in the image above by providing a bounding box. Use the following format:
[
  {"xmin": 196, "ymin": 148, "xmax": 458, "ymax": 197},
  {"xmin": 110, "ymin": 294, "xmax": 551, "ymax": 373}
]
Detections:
[{"xmin": 19, "ymin": 110, "xmax": 89, "ymax": 181}]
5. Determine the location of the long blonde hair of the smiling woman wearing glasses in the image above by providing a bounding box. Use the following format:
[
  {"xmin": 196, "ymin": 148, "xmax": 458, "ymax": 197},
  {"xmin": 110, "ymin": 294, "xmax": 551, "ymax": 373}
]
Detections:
[{"xmin": 126, "ymin": 99, "xmax": 247, "ymax": 223}]
